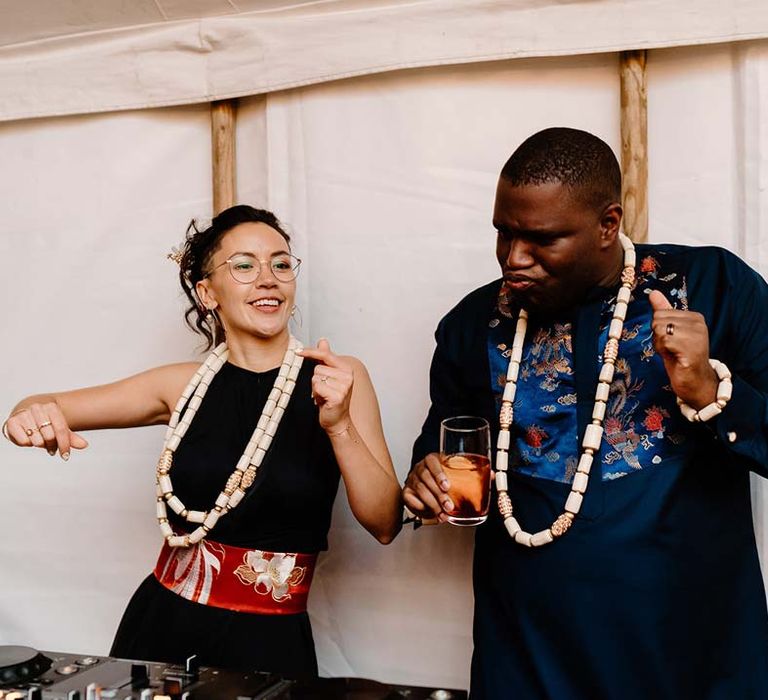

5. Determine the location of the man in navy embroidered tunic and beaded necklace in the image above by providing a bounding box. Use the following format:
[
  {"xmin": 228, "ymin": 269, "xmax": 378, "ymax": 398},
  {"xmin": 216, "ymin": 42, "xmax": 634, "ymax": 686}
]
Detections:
[{"xmin": 403, "ymin": 128, "xmax": 768, "ymax": 700}]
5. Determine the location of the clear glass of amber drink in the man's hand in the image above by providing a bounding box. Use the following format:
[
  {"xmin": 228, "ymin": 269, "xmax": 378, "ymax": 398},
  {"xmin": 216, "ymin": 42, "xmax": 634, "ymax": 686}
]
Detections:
[{"xmin": 440, "ymin": 416, "xmax": 491, "ymax": 525}]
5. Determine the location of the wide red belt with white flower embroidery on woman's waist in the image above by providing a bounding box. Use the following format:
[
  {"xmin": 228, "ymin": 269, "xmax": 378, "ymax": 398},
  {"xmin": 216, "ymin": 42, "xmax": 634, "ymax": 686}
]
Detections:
[{"xmin": 154, "ymin": 540, "xmax": 317, "ymax": 615}]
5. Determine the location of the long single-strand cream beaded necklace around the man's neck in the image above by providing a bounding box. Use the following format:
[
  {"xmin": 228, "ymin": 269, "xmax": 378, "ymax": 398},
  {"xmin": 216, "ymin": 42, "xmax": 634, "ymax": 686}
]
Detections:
[{"xmin": 496, "ymin": 233, "xmax": 636, "ymax": 547}]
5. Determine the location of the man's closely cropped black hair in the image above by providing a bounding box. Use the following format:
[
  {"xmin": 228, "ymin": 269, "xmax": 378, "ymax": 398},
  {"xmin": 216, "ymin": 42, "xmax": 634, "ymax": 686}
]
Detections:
[{"xmin": 501, "ymin": 127, "xmax": 621, "ymax": 210}]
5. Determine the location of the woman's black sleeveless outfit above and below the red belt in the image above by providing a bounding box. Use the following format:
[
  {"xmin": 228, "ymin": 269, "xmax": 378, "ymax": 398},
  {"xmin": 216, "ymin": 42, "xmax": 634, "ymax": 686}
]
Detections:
[{"xmin": 111, "ymin": 360, "xmax": 340, "ymax": 678}]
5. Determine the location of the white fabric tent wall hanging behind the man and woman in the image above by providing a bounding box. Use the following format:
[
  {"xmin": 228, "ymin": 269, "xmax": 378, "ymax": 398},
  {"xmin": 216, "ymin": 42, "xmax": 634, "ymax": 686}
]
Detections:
[{"xmin": 0, "ymin": 41, "xmax": 768, "ymax": 687}]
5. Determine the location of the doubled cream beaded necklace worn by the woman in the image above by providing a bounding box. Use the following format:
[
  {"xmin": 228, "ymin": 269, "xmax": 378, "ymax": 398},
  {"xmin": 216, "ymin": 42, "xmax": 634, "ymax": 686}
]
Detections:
[{"xmin": 157, "ymin": 336, "xmax": 304, "ymax": 547}]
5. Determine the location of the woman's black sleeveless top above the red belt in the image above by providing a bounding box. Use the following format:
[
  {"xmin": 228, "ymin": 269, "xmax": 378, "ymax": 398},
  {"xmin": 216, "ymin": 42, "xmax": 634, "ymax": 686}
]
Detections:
[{"xmin": 169, "ymin": 360, "xmax": 340, "ymax": 552}]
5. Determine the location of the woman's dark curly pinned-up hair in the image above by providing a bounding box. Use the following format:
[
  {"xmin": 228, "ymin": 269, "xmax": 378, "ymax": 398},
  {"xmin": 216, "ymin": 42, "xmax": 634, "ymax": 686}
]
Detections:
[{"xmin": 179, "ymin": 204, "xmax": 291, "ymax": 350}]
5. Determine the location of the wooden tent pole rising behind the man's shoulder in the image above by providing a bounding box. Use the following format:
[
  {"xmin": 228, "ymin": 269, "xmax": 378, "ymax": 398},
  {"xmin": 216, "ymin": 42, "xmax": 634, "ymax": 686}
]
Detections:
[{"xmin": 619, "ymin": 50, "xmax": 648, "ymax": 242}]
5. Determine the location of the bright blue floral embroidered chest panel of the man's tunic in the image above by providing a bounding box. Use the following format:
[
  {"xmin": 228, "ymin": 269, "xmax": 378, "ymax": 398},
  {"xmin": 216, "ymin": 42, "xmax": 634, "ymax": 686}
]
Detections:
[{"xmin": 488, "ymin": 246, "xmax": 688, "ymax": 482}]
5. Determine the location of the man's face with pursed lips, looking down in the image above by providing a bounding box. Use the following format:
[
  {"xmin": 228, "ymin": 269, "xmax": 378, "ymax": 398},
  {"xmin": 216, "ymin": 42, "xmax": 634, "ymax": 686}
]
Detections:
[{"xmin": 493, "ymin": 178, "xmax": 621, "ymax": 312}]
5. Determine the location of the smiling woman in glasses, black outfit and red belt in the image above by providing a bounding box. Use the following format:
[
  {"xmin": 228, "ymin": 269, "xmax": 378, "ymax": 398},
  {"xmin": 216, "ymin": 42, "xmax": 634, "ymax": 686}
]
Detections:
[{"xmin": 3, "ymin": 206, "xmax": 401, "ymax": 677}]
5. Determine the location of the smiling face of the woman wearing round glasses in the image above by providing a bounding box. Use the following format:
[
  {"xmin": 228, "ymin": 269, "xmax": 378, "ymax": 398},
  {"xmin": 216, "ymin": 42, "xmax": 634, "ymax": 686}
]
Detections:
[{"xmin": 196, "ymin": 222, "xmax": 296, "ymax": 338}]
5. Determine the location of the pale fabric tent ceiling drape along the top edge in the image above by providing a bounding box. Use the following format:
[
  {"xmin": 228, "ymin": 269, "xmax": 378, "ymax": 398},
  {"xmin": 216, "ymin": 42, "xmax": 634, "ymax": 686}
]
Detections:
[{"xmin": 0, "ymin": 0, "xmax": 768, "ymax": 121}]
